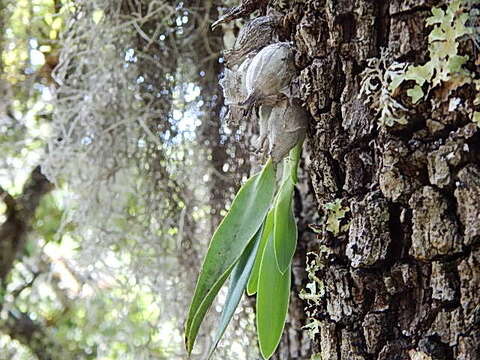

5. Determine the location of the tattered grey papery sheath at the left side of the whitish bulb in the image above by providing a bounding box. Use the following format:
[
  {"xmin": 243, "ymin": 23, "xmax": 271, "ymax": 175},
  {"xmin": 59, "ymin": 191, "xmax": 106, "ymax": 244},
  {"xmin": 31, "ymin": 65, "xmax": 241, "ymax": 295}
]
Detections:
[{"xmin": 220, "ymin": 58, "xmax": 252, "ymax": 105}]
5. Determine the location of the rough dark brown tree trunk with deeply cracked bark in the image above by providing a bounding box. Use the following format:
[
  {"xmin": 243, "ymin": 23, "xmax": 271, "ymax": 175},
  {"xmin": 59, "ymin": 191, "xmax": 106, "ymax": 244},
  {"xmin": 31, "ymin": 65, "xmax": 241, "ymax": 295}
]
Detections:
[{"xmin": 270, "ymin": 0, "xmax": 480, "ymax": 360}]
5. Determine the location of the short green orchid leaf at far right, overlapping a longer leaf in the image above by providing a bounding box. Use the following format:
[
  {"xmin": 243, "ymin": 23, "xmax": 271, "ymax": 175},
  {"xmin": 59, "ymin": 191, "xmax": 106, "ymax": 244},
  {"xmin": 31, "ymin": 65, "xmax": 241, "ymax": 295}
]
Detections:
[{"xmin": 273, "ymin": 177, "xmax": 298, "ymax": 274}]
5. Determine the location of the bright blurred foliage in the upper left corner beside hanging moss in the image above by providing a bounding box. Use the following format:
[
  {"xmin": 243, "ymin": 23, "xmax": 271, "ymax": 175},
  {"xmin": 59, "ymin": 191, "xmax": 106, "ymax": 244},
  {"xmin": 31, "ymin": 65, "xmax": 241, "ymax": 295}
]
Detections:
[{"xmin": 0, "ymin": 0, "xmax": 65, "ymax": 167}]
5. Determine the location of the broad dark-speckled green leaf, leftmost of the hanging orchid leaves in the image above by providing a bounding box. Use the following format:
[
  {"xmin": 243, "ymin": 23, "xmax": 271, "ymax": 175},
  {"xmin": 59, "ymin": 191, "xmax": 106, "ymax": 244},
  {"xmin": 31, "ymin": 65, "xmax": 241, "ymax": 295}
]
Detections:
[{"xmin": 185, "ymin": 160, "xmax": 275, "ymax": 354}]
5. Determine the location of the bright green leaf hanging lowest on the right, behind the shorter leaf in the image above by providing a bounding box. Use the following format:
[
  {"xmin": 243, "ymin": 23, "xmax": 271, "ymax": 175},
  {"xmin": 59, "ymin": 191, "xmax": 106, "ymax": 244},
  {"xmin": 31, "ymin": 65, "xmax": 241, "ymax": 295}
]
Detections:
[{"xmin": 257, "ymin": 233, "xmax": 291, "ymax": 359}]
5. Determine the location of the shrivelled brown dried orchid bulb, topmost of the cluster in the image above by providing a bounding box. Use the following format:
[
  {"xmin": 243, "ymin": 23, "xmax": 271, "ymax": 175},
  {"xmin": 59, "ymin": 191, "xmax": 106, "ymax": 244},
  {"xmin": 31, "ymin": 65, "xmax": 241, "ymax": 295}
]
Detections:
[{"xmin": 225, "ymin": 16, "xmax": 279, "ymax": 66}]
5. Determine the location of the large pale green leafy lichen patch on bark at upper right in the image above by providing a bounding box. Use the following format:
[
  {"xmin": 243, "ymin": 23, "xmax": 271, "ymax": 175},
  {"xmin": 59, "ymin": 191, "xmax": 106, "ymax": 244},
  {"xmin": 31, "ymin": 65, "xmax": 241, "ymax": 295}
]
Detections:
[{"xmin": 360, "ymin": 0, "xmax": 480, "ymax": 126}]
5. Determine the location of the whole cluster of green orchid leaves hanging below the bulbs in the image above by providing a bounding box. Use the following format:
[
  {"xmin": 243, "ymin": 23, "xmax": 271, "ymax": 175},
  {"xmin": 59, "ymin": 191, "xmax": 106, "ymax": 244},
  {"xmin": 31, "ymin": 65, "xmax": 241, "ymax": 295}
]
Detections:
[{"xmin": 185, "ymin": 141, "xmax": 303, "ymax": 359}]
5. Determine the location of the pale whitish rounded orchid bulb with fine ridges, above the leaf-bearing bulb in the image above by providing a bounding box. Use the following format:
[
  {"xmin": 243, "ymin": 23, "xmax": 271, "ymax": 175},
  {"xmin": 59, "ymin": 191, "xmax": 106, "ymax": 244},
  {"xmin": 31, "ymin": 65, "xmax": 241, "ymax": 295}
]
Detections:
[{"xmin": 243, "ymin": 42, "xmax": 296, "ymax": 106}]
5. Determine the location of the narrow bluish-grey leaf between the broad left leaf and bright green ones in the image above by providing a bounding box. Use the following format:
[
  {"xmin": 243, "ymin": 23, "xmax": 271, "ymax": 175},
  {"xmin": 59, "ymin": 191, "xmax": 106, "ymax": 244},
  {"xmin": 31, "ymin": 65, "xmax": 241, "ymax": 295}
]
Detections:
[{"xmin": 208, "ymin": 226, "xmax": 264, "ymax": 359}]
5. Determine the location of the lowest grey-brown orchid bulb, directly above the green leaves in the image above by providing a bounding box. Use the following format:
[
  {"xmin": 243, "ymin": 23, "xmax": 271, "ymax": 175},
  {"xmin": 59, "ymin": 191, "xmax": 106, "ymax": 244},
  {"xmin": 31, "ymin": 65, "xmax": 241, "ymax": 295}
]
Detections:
[{"xmin": 268, "ymin": 100, "xmax": 308, "ymax": 163}]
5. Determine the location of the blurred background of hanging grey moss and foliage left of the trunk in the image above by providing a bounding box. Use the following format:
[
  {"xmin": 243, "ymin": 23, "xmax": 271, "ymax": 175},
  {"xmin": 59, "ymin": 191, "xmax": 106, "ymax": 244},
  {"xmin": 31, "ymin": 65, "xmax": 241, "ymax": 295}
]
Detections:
[{"xmin": 0, "ymin": 0, "xmax": 257, "ymax": 360}]
